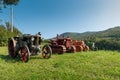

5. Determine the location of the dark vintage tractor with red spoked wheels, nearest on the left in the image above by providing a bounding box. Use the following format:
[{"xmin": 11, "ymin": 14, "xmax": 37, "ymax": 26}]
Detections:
[{"xmin": 8, "ymin": 33, "xmax": 52, "ymax": 62}]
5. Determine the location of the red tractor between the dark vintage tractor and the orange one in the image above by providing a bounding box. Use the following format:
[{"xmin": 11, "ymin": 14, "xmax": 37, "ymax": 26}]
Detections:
[{"xmin": 49, "ymin": 35, "xmax": 76, "ymax": 54}]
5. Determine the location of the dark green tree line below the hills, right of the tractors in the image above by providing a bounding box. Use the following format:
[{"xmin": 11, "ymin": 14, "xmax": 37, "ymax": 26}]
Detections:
[{"xmin": 85, "ymin": 36, "xmax": 120, "ymax": 50}]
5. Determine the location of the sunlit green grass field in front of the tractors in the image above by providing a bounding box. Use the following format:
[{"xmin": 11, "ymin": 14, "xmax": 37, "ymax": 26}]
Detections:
[{"xmin": 0, "ymin": 47, "xmax": 120, "ymax": 80}]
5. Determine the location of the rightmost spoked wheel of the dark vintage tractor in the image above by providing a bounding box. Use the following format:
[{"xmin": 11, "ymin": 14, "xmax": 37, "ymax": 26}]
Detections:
[{"xmin": 42, "ymin": 45, "xmax": 52, "ymax": 59}]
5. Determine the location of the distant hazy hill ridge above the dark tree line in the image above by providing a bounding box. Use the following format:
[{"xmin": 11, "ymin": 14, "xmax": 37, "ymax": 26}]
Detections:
[{"xmin": 56, "ymin": 26, "xmax": 120, "ymax": 40}]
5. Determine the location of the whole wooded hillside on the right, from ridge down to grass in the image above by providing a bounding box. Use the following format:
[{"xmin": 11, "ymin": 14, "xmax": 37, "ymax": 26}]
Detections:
[{"xmin": 50, "ymin": 26, "xmax": 120, "ymax": 51}]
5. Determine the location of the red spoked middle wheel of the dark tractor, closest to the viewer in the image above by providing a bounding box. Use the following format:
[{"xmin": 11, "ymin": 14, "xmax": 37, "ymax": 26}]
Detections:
[{"xmin": 19, "ymin": 45, "xmax": 30, "ymax": 62}]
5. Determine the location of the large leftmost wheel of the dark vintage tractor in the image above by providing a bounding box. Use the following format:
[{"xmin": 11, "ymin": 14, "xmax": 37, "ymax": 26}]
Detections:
[{"xmin": 8, "ymin": 38, "xmax": 17, "ymax": 58}]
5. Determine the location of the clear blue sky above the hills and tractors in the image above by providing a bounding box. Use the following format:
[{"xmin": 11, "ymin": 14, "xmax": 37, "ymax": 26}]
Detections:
[{"xmin": 0, "ymin": 0, "xmax": 120, "ymax": 39}]
